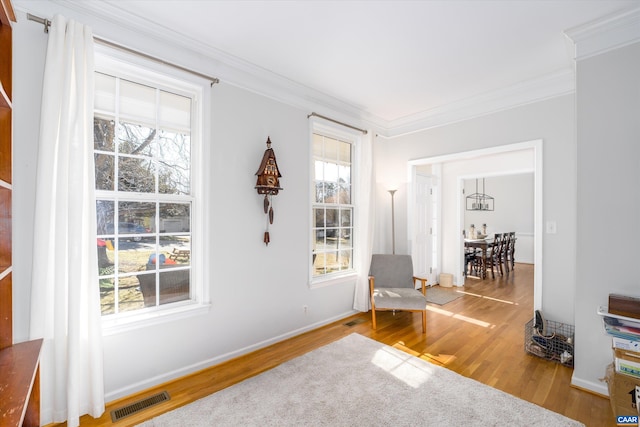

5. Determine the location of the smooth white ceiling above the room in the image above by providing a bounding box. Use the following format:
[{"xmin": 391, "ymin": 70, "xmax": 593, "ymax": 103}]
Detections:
[{"xmin": 16, "ymin": 0, "xmax": 640, "ymax": 133}]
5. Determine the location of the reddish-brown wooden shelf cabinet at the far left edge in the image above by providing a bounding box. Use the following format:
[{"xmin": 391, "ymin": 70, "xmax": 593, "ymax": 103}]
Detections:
[{"xmin": 0, "ymin": 0, "xmax": 42, "ymax": 427}]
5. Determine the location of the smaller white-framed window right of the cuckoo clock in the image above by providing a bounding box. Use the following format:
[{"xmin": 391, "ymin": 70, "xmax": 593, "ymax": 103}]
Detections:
[{"xmin": 311, "ymin": 127, "xmax": 356, "ymax": 282}]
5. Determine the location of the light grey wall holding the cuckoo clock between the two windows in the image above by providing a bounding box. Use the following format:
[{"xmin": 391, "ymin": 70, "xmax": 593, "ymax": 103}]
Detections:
[{"xmin": 13, "ymin": 2, "xmax": 354, "ymax": 420}]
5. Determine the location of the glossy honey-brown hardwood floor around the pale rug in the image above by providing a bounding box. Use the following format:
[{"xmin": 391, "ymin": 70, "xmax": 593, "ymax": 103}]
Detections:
[{"xmin": 65, "ymin": 264, "xmax": 616, "ymax": 427}]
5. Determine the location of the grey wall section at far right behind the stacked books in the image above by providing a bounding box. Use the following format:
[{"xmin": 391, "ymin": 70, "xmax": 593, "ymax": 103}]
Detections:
[{"xmin": 573, "ymin": 43, "xmax": 640, "ymax": 393}]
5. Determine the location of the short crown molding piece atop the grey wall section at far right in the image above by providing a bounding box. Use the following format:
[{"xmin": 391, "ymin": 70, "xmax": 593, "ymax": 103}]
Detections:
[{"xmin": 565, "ymin": 7, "xmax": 640, "ymax": 60}]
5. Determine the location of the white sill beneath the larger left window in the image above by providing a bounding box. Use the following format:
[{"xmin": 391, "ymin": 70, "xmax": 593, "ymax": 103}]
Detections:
[{"xmin": 102, "ymin": 301, "xmax": 211, "ymax": 336}]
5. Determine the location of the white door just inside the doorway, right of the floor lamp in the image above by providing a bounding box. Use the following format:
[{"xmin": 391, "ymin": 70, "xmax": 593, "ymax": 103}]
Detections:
[{"xmin": 411, "ymin": 173, "xmax": 438, "ymax": 285}]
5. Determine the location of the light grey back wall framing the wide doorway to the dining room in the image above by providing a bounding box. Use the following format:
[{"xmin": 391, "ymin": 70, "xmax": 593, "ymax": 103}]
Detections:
[{"xmin": 374, "ymin": 95, "xmax": 576, "ymax": 327}]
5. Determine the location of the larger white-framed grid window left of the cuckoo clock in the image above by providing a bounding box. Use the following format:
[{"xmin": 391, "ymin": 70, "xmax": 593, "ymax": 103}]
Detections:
[{"xmin": 94, "ymin": 51, "xmax": 203, "ymax": 318}]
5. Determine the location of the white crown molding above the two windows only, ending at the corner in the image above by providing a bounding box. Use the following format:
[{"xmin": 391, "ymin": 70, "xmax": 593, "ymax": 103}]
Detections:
[{"xmin": 14, "ymin": 0, "xmax": 385, "ymax": 129}]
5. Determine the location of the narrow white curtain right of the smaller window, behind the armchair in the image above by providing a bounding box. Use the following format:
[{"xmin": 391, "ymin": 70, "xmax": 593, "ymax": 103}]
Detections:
[{"xmin": 353, "ymin": 131, "xmax": 375, "ymax": 311}]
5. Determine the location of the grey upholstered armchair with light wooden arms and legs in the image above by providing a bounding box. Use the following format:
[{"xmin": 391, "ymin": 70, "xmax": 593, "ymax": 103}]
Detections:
[{"xmin": 369, "ymin": 255, "xmax": 427, "ymax": 333}]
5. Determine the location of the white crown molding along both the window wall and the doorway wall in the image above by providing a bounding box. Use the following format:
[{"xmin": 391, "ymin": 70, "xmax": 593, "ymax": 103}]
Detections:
[{"xmin": 14, "ymin": 0, "xmax": 592, "ymax": 137}]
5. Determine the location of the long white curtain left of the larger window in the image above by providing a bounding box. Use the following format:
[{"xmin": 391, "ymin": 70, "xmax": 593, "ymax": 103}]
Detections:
[{"xmin": 30, "ymin": 16, "xmax": 104, "ymax": 427}]
